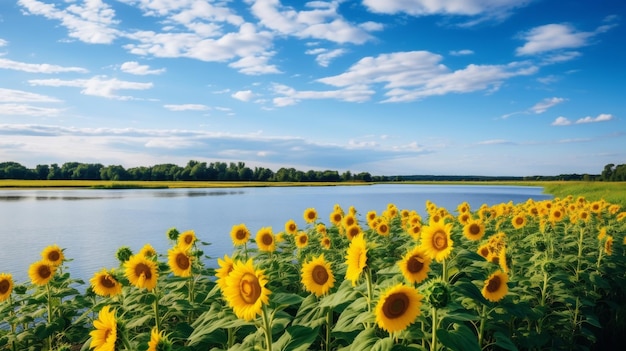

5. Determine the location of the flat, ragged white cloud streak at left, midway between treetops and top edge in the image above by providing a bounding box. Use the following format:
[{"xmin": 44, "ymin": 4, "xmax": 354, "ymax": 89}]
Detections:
[{"xmin": 28, "ymin": 76, "xmax": 152, "ymax": 100}]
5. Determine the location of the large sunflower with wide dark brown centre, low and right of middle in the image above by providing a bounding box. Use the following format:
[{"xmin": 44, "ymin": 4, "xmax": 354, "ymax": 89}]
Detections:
[{"xmin": 375, "ymin": 284, "xmax": 423, "ymax": 333}]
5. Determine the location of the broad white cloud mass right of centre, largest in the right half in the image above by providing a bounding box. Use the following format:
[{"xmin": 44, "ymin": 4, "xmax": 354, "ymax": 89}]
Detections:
[{"xmin": 317, "ymin": 51, "xmax": 537, "ymax": 102}]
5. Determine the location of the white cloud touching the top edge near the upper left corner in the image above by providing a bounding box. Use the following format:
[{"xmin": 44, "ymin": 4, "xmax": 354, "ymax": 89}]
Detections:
[{"xmin": 18, "ymin": 0, "xmax": 120, "ymax": 44}]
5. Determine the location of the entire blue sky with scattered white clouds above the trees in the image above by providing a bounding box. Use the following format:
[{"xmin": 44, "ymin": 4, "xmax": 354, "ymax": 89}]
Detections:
[{"xmin": 0, "ymin": 0, "xmax": 626, "ymax": 176}]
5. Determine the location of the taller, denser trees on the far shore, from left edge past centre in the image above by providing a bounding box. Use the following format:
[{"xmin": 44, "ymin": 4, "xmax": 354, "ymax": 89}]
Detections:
[{"xmin": 0, "ymin": 160, "xmax": 378, "ymax": 182}]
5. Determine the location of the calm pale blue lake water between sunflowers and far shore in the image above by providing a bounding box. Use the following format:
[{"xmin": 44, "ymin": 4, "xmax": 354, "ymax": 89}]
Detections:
[{"xmin": 0, "ymin": 184, "xmax": 551, "ymax": 283}]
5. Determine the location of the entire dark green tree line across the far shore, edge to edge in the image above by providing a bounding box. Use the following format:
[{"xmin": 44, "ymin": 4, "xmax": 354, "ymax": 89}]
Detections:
[{"xmin": 0, "ymin": 160, "xmax": 626, "ymax": 182}]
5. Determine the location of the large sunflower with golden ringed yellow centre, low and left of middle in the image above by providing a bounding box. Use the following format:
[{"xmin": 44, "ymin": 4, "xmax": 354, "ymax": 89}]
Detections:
[{"xmin": 224, "ymin": 259, "xmax": 271, "ymax": 321}]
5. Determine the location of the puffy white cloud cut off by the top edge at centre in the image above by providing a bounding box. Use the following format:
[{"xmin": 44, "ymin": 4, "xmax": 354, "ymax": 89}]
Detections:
[{"xmin": 247, "ymin": 0, "xmax": 380, "ymax": 44}]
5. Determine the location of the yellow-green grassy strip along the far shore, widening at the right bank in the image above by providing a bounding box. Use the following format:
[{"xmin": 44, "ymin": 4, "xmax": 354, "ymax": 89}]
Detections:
[{"xmin": 0, "ymin": 179, "xmax": 626, "ymax": 208}]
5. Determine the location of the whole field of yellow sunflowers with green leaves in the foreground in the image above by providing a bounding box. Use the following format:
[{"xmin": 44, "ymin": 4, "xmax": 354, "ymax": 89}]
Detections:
[{"xmin": 0, "ymin": 196, "xmax": 626, "ymax": 351}]
